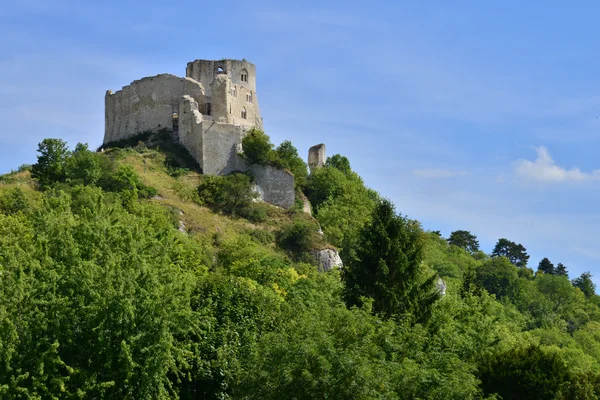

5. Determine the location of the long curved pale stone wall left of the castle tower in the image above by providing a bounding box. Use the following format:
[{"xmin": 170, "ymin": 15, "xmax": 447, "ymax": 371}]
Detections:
[{"xmin": 104, "ymin": 74, "xmax": 205, "ymax": 143}]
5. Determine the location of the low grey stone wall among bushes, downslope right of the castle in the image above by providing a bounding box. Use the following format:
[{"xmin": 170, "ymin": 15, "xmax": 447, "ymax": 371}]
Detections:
[{"xmin": 248, "ymin": 164, "xmax": 296, "ymax": 208}]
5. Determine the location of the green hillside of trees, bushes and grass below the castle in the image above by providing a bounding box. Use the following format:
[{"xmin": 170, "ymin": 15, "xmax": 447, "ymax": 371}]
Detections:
[{"xmin": 0, "ymin": 139, "xmax": 600, "ymax": 399}]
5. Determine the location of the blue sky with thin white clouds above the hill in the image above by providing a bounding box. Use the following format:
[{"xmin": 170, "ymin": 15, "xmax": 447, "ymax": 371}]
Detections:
[{"xmin": 0, "ymin": 0, "xmax": 600, "ymax": 284}]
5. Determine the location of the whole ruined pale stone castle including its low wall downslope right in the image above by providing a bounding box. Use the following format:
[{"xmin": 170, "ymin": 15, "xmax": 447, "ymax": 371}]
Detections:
[{"xmin": 103, "ymin": 60, "xmax": 294, "ymax": 208}]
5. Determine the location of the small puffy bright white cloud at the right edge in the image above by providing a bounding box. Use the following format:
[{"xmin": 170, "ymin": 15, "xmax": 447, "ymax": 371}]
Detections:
[{"xmin": 515, "ymin": 146, "xmax": 600, "ymax": 182}]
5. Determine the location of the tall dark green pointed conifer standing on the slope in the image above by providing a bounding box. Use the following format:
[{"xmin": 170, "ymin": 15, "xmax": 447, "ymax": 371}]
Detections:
[{"xmin": 343, "ymin": 199, "xmax": 438, "ymax": 322}]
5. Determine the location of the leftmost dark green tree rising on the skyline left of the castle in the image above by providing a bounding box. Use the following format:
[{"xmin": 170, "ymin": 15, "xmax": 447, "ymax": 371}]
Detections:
[{"xmin": 31, "ymin": 139, "xmax": 70, "ymax": 188}]
